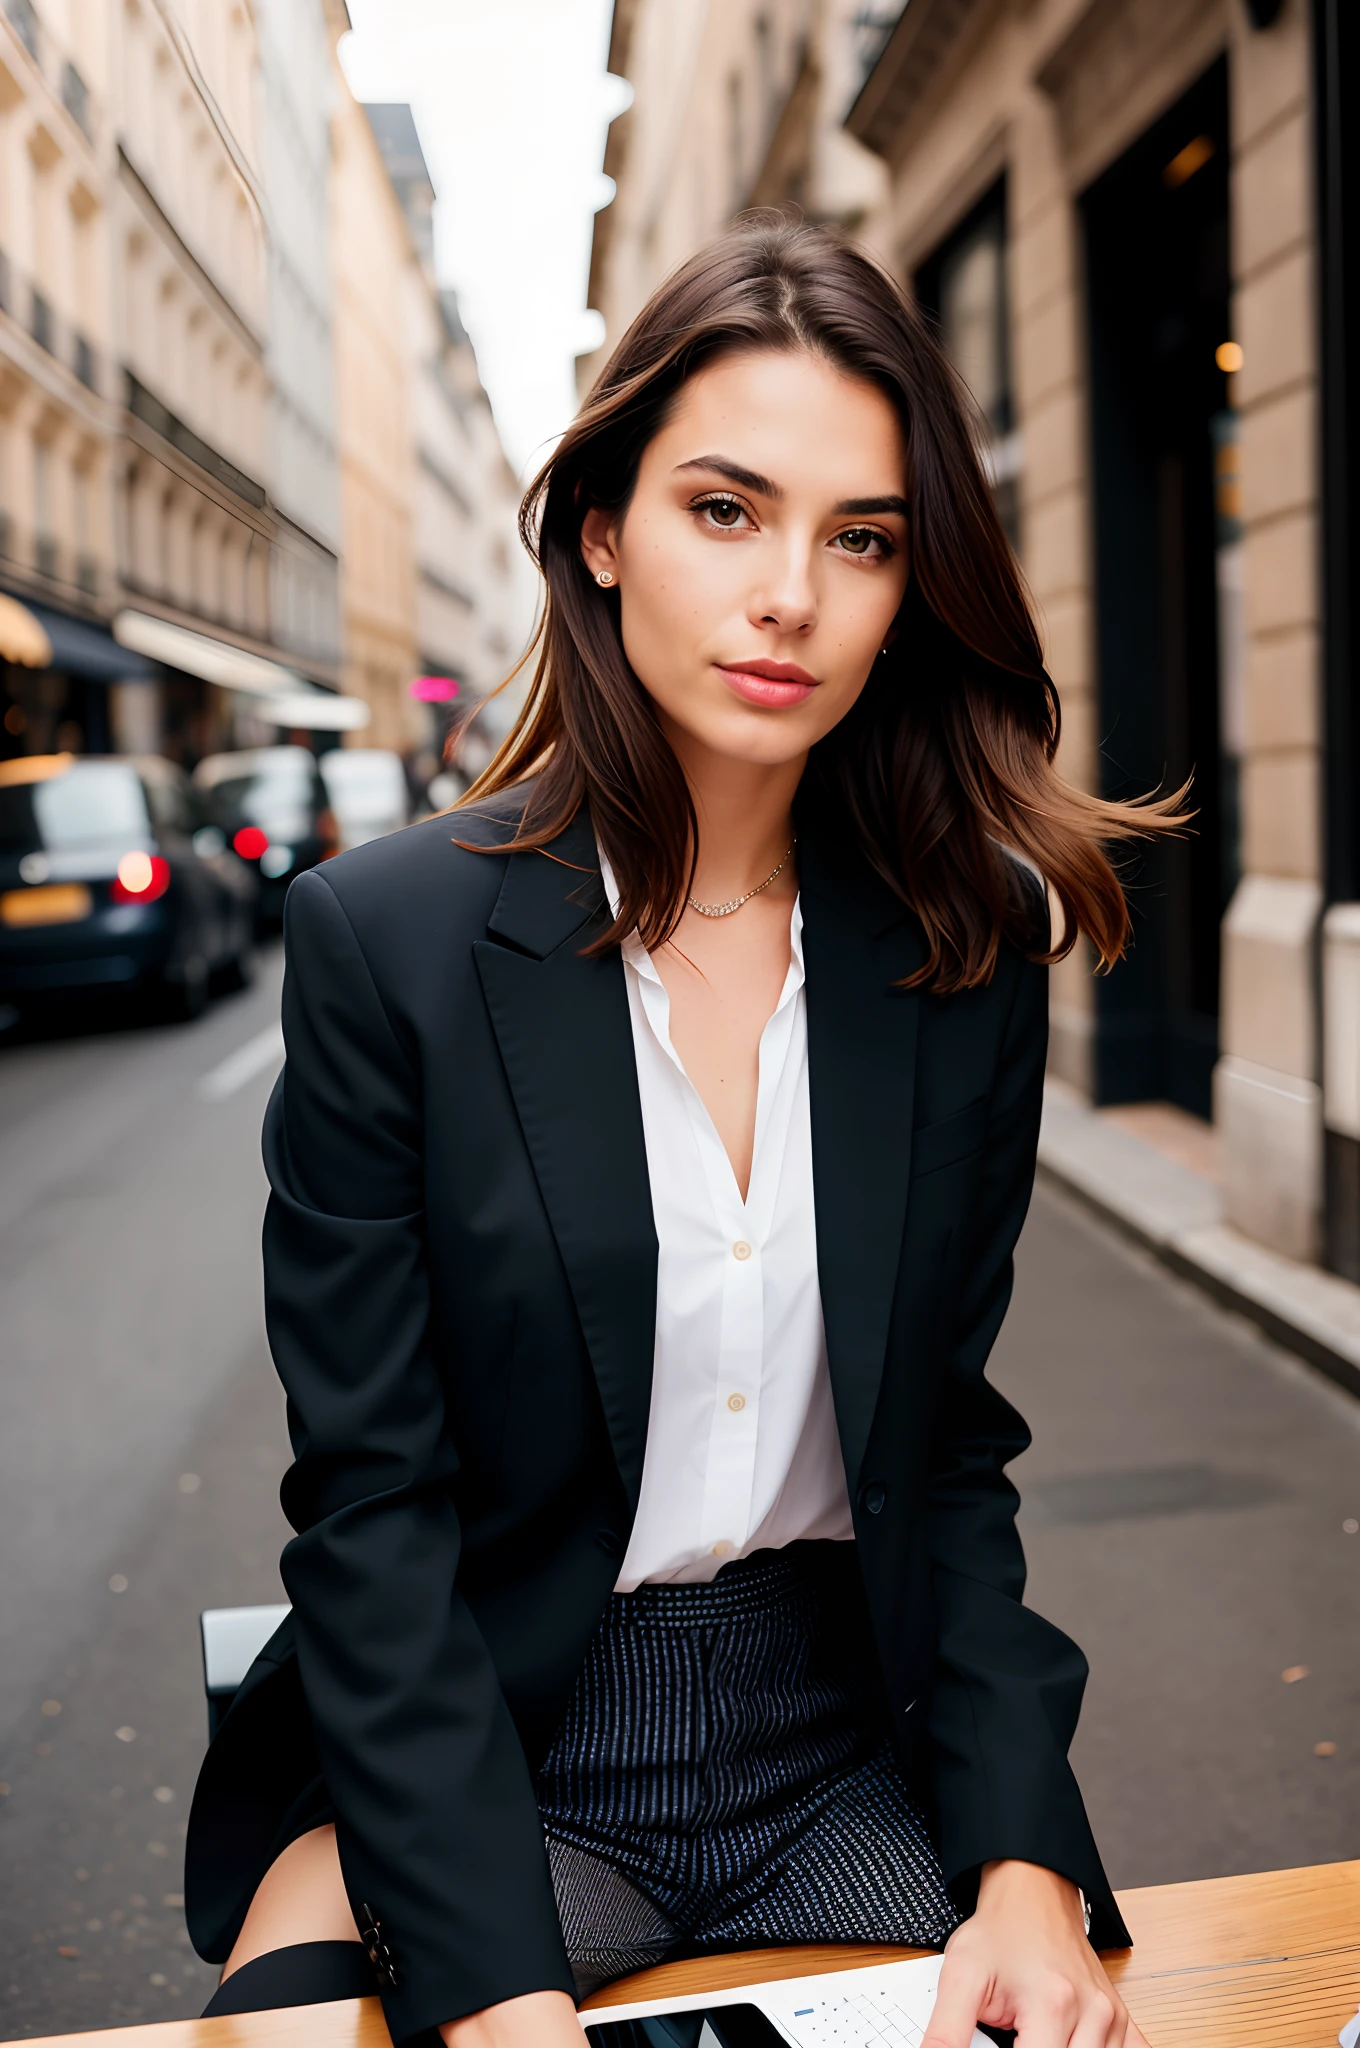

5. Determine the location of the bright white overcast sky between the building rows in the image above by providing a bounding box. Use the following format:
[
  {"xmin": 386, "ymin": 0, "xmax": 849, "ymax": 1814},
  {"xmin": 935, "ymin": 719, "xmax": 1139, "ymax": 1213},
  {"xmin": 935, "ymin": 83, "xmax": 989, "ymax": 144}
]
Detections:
[{"xmin": 340, "ymin": 0, "xmax": 627, "ymax": 471}]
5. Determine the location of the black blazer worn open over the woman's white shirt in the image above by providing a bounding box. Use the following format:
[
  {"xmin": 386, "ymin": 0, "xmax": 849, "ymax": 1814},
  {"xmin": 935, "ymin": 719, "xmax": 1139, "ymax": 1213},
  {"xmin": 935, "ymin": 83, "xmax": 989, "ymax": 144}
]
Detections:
[{"xmin": 186, "ymin": 793, "xmax": 1127, "ymax": 2040}]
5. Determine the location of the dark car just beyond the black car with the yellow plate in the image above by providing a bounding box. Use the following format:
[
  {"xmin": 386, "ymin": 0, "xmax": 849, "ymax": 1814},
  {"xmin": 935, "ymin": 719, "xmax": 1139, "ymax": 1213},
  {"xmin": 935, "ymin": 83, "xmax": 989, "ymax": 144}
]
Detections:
[{"xmin": 195, "ymin": 748, "xmax": 338, "ymax": 924}]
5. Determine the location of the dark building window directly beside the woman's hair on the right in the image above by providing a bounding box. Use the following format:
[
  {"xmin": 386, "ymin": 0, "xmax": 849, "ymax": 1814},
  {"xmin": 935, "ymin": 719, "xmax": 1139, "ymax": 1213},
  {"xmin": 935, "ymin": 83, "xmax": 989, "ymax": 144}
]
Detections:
[{"xmin": 913, "ymin": 178, "xmax": 1020, "ymax": 547}]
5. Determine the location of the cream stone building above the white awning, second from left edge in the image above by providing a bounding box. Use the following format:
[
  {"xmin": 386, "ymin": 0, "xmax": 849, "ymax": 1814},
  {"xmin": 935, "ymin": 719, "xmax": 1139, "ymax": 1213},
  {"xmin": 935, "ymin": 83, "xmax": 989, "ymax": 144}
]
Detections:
[{"xmin": 107, "ymin": 0, "xmax": 279, "ymax": 754}]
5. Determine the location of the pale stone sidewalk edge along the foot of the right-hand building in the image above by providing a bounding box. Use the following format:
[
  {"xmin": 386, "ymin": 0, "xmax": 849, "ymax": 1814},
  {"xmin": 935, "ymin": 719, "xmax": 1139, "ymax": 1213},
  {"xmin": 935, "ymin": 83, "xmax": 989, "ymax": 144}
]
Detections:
[{"xmin": 1038, "ymin": 1081, "xmax": 1360, "ymax": 1397}]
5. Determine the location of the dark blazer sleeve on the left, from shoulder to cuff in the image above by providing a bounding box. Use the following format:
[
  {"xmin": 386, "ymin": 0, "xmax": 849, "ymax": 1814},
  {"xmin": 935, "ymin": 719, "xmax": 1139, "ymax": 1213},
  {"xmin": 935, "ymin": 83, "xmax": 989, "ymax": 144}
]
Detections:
[{"xmin": 264, "ymin": 872, "xmax": 571, "ymax": 2042}]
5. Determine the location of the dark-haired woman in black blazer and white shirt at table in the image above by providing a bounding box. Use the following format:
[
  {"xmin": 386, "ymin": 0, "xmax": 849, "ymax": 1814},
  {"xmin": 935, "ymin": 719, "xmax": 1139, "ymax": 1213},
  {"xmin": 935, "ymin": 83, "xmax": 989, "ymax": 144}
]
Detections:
[{"xmin": 188, "ymin": 221, "xmax": 1170, "ymax": 2048}]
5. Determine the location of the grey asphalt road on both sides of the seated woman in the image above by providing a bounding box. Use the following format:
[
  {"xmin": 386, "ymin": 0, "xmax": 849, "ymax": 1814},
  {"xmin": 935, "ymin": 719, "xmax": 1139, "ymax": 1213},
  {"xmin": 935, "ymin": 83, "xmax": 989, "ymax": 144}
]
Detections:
[{"xmin": 0, "ymin": 958, "xmax": 1360, "ymax": 2036}]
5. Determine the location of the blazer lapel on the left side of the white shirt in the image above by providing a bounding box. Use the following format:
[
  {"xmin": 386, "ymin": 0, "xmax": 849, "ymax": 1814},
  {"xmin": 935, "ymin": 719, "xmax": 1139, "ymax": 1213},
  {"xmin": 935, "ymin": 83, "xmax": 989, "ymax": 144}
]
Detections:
[{"xmin": 473, "ymin": 807, "xmax": 657, "ymax": 1509}]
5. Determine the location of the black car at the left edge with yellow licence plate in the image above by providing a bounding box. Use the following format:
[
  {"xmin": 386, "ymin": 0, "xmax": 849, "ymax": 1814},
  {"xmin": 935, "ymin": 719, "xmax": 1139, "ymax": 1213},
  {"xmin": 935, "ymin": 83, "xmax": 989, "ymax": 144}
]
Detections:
[{"xmin": 0, "ymin": 754, "xmax": 256, "ymax": 1018}]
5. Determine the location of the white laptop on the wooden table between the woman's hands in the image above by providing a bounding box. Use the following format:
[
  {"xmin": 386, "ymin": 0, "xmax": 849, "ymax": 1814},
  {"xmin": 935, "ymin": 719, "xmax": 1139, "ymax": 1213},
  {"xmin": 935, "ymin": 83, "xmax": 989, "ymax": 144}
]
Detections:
[{"xmin": 582, "ymin": 1956, "xmax": 989, "ymax": 2048}]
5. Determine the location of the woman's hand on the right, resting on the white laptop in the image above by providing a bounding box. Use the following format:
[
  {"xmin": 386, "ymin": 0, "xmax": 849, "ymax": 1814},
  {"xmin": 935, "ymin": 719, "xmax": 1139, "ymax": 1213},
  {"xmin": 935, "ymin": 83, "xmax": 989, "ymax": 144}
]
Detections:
[{"xmin": 922, "ymin": 1862, "xmax": 1147, "ymax": 2048}]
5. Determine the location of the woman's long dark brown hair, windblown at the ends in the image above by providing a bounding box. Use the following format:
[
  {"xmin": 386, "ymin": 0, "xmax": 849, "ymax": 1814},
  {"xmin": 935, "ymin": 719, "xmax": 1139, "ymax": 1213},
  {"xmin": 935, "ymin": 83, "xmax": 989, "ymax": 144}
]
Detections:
[{"xmin": 463, "ymin": 215, "xmax": 1178, "ymax": 993}]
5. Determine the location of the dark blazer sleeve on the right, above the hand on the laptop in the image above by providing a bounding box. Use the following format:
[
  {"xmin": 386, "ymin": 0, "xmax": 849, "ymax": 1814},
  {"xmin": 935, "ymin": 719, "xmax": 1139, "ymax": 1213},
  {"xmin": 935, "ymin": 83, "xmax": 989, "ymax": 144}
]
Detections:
[{"xmin": 928, "ymin": 961, "xmax": 1129, "ymax": 1948}]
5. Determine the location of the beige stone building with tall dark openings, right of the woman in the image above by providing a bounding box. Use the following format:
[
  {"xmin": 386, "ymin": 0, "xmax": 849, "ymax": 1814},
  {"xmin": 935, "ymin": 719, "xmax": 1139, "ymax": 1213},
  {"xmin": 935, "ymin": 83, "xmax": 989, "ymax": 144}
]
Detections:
[{"xmin": 584, "ymin": 0, "xmax": 1360, "ymax": 1278}]
